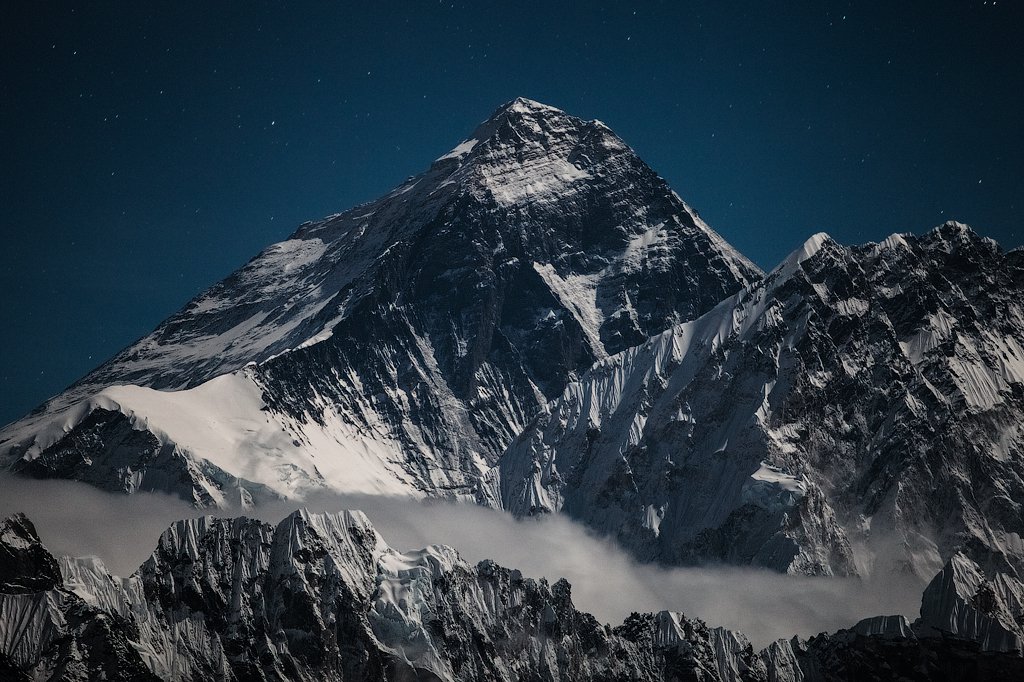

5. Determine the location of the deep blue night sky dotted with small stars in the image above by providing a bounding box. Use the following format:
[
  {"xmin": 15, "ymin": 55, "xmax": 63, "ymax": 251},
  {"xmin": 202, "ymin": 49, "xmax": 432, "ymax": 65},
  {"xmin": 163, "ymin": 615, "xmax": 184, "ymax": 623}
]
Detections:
[{"xmin": 0, "ymin": 0, "xmax": 1024, "ymax": 423}]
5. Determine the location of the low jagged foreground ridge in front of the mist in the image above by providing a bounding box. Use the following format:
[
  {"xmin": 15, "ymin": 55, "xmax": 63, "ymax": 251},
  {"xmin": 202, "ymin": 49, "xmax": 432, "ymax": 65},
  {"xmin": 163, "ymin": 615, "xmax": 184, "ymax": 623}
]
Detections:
[{"xmin": 8, "ymin": 511, "xmax": 1024, "ymax": 682}]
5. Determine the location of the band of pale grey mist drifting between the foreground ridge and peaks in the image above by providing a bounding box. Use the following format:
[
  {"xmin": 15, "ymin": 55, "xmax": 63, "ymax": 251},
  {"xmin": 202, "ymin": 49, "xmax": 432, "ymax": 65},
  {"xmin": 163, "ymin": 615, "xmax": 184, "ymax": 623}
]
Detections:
[{"xmin": 0, "ymin": 476, "xmax": 923, "ymax": 648}]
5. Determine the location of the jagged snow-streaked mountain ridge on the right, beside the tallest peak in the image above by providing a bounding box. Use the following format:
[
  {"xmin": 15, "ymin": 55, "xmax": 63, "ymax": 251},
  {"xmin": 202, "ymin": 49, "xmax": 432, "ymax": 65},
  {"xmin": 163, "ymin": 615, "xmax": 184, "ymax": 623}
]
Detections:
[{"xmin": 478, "ymin": 222, "xmax": 1024, "ymax": 579}]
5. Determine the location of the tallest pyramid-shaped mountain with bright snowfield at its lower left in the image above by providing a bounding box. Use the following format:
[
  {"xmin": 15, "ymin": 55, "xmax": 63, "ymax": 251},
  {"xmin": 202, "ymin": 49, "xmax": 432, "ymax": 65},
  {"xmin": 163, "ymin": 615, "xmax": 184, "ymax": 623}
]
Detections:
[{"xmin": 0, "ymin": 98, "xmax": 761, "ymax": 506}]
